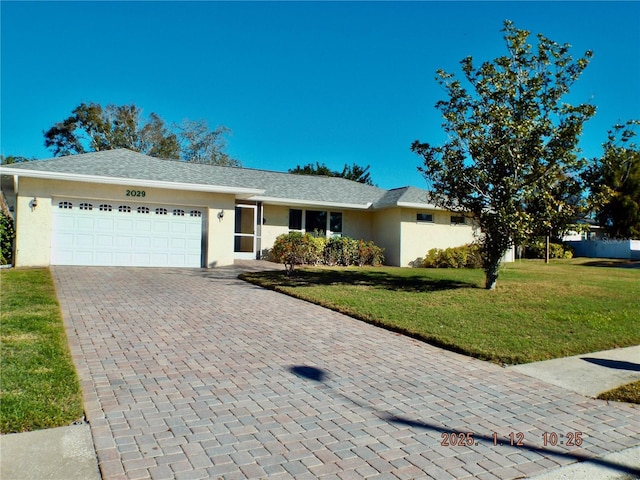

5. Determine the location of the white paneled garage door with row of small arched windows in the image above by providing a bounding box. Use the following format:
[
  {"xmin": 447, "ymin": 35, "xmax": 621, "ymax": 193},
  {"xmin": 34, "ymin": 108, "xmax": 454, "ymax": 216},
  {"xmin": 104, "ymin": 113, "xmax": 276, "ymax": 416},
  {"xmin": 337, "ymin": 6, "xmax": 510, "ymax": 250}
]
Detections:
[{"xmin": 51, "ymin": 199, "xmax": 202, "ymax": 268}]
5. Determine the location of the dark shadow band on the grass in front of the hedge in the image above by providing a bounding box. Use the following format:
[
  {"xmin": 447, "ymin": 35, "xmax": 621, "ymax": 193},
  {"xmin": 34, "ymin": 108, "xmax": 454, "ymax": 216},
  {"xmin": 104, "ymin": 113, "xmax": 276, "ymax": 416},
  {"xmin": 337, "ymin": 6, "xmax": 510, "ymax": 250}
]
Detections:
[{"xmin": 263, "ymin": 270, "xmax": 480, "ymax": 293}]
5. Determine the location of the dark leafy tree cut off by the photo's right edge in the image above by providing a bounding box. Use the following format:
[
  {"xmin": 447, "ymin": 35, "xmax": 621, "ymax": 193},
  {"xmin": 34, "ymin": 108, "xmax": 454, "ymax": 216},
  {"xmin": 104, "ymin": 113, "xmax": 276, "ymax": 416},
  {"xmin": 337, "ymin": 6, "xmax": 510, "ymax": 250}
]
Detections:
[{"xmin": 583, "ymin": 120, "xmax": 640, "ymax": 239}]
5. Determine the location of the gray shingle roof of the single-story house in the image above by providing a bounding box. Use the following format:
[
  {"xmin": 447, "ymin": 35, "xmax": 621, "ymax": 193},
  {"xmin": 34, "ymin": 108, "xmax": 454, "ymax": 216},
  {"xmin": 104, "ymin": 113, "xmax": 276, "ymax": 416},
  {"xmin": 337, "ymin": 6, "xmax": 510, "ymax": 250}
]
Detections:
[{"xmin": 1, "ymin": 149, "xmax": 436, "ymax": 208}]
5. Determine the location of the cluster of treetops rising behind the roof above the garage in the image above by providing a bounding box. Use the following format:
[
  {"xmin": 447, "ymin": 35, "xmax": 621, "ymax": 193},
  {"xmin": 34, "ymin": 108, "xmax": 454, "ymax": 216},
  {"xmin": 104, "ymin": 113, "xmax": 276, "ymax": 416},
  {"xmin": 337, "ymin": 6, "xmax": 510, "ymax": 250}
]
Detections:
[{"xmin": 44, "ymin": 103, "xmax": 240, "ymax": 166}]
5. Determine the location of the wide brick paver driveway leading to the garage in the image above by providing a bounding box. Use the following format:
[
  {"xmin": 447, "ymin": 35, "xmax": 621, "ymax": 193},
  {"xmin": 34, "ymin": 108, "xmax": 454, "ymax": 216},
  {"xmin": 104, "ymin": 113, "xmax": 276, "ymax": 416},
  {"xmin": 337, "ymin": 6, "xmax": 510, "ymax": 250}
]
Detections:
[{"xmin": 52, "ymin": 267, "xmax": 640, "ymax": 479}]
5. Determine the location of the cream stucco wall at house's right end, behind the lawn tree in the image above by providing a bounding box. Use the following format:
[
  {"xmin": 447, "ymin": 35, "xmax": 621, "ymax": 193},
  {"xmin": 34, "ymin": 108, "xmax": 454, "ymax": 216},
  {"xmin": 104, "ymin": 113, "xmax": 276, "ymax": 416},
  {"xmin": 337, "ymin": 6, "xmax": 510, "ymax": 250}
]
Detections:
[{"xmin": 398, "ymin": 208, "xmax": 475, "ymax": 267}]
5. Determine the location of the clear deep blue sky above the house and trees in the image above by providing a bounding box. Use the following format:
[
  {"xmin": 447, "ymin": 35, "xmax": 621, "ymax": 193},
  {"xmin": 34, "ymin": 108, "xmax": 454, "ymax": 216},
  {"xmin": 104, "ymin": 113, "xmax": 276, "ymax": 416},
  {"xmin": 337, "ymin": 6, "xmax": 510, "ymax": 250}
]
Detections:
[{"xmin": 0, "ymin": 0, "xmax": 640, "ymax": 188}]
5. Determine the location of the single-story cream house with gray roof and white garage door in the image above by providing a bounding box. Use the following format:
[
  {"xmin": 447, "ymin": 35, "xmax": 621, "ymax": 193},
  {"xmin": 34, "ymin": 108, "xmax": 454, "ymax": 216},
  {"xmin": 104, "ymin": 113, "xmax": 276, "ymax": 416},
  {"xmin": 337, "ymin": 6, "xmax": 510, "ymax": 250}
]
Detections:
[{"xmin": 0, "ymin": 149, "xmax": 476, "ymax": 268}]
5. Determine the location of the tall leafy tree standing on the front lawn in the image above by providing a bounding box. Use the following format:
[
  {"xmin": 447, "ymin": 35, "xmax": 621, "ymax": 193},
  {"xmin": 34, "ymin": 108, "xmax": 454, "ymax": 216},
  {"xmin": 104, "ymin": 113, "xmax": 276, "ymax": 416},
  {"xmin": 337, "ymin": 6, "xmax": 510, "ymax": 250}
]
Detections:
[{"xmin": 411, "ymin": 21, "xmax": 595, "ymax": 289}]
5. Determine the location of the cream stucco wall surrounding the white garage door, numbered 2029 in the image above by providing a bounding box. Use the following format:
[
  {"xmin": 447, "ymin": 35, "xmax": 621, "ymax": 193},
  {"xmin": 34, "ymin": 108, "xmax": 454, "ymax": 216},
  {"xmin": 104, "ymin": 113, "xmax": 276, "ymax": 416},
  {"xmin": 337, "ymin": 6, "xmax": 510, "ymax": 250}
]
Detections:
[{"xmin": 15, "ymin": 177, "xmax": 235, "ymax": 267}]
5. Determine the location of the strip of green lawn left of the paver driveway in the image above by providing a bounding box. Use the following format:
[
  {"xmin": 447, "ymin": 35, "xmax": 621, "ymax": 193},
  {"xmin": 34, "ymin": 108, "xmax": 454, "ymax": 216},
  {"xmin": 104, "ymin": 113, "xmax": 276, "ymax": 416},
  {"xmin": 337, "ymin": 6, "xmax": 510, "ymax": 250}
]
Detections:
[{"xmin": 0, "ymin": 269, "xmax": 83, "ymax": 433}]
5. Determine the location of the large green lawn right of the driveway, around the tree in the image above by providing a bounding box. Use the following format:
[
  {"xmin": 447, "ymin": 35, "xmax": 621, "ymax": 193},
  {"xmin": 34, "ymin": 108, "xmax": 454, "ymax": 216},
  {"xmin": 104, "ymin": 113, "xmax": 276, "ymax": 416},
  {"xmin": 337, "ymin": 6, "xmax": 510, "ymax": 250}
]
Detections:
[{"xmin": 241, "ymin": 259, "xmax": 640, "ymax": 364}]
